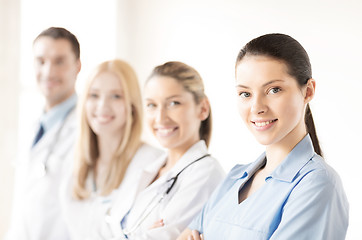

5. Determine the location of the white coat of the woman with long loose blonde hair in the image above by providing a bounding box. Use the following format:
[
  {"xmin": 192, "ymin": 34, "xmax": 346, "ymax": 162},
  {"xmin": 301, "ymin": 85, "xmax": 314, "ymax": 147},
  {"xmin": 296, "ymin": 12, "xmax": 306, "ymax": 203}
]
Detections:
[{"xmin": 61, "ymin": 144, "xmax": 163, "ymax": 240}]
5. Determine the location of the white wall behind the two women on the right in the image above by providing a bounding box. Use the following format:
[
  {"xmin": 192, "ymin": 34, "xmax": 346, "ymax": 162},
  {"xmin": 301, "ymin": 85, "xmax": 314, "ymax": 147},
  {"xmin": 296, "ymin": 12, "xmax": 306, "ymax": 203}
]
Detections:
[{"xmin": 118, "ymin": 0, "xmax": 362, "ymax": 240}]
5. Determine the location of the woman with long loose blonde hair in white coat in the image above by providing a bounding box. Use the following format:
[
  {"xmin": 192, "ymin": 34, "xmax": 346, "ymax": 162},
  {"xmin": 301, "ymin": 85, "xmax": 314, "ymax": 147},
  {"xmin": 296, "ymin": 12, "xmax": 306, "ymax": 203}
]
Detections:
[{"xmin": 62, "ymin": 60, "xmax": 161, "ymax": 239}]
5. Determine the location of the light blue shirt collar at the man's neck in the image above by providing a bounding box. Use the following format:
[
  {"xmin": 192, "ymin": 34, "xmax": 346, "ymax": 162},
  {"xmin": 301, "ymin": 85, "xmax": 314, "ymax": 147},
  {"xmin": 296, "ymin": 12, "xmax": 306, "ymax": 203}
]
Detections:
[{"xmin": 40, "ymin": 94, "xmax": 77, "ymax": 131}]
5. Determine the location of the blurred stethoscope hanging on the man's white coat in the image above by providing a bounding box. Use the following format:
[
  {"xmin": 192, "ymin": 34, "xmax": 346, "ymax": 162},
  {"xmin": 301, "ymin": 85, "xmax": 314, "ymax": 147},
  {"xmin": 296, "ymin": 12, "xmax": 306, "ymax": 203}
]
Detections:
[{"xmin": 36, "ymin": 105, "xmax": 75, "ymax": 178}]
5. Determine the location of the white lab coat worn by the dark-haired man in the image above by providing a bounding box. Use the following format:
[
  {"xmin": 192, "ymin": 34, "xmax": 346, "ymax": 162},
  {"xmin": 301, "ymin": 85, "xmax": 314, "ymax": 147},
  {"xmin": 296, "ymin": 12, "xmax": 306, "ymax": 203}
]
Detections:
[{"xmin": 5, "ymin": 109, "xmax": 76, "ymax": 240}]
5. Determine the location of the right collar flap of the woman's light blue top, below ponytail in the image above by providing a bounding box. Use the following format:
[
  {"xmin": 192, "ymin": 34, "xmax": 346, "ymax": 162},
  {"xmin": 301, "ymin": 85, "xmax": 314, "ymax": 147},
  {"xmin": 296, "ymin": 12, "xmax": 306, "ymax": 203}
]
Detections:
[{"xmin": 271, "ymin": 134, "xmax": 315, "ymax": 182}]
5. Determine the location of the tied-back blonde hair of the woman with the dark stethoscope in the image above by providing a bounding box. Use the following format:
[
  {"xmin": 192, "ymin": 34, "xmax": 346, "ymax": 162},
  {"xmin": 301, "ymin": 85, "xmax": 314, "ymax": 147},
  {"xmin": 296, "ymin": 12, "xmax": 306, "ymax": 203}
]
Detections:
[{"xmin": 148, "ymin": 61, "xmax": 212, "ymax": 146}]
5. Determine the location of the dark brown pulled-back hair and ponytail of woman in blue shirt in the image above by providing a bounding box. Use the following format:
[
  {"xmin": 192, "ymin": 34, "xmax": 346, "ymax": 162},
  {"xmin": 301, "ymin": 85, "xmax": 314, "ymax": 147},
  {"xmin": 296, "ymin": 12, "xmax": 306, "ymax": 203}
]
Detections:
[{"xmin": 236, "ymin": 33, "xmax": 322, "ymax": 156}]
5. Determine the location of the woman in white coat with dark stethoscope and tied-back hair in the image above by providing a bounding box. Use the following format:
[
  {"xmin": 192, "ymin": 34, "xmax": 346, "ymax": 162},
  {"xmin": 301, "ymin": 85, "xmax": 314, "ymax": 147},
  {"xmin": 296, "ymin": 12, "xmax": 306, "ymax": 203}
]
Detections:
[{"xmin": 104, "ymin": 62, "xmax": 224, "ymax": 240}]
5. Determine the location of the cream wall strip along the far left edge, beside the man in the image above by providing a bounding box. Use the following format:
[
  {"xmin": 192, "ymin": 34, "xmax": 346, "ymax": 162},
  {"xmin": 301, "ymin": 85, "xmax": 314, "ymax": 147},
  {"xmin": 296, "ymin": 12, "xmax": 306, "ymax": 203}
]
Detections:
[{"xmin": 0, "ymin": 0, "xmax": 20, "ymax": 238}]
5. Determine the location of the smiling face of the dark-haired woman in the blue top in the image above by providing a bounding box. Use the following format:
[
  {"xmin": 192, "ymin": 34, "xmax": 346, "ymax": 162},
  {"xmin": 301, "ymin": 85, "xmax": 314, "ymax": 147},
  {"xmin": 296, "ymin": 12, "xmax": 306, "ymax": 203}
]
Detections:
[{"xmin": 236, "ymin": 56, "xmax": 307, "ymax": 146}]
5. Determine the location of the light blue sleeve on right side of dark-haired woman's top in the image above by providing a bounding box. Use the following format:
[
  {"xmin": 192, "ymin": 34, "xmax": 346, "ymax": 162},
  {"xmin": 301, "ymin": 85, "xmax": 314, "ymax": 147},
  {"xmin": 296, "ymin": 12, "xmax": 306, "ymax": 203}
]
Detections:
[{"xmin": 270, "ymin": 168, "xmax": 349, "ymax": 240}]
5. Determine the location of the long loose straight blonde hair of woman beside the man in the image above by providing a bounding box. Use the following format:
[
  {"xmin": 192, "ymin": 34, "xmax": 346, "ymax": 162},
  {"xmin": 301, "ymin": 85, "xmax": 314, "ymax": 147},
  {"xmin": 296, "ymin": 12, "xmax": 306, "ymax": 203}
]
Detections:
[{"xmin": 73, "ymin": 59, "xmax": 143, "ymax": 200}]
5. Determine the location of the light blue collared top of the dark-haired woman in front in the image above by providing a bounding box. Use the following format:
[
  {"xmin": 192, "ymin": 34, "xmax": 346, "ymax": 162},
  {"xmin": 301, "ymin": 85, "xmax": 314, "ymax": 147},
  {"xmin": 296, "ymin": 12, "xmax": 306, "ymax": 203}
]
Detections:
[{"xmin": 189, "ymin": 135, "xmax": 349, "ymax": 240}]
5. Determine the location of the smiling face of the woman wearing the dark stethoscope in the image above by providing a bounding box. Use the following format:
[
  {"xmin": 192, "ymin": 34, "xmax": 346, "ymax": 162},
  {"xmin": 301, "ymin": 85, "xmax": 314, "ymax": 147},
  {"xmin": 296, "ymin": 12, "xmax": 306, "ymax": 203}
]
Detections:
[{"xmin": 145, "ymin": 76, "xmax": 202, "ymax": 152}]
